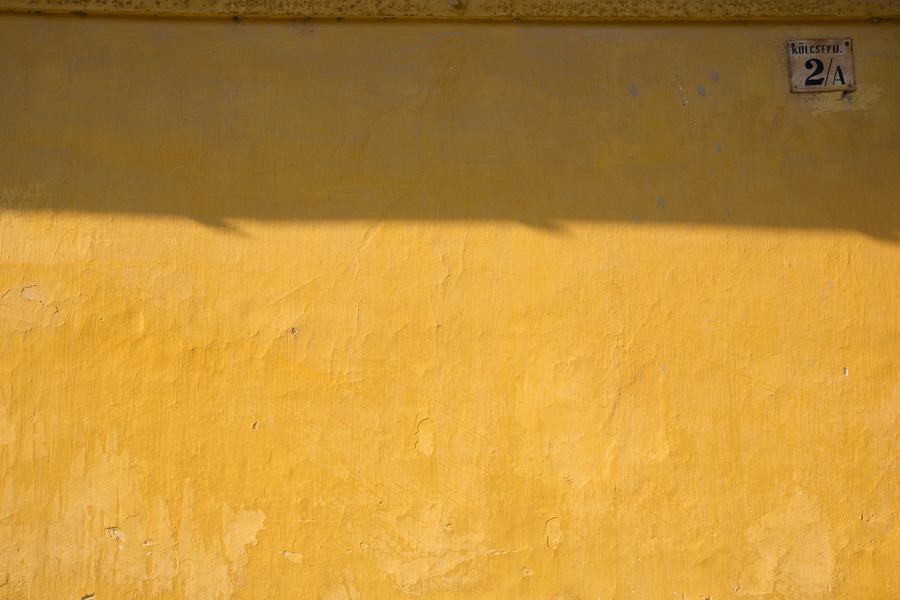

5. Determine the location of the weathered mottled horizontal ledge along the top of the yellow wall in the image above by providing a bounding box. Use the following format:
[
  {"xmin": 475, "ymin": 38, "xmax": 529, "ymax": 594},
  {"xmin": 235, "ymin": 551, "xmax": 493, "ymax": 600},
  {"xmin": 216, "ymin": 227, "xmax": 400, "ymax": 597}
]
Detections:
[{"xmin": 0, "ymin": 0, "xmax": 900, "ymax": 21}]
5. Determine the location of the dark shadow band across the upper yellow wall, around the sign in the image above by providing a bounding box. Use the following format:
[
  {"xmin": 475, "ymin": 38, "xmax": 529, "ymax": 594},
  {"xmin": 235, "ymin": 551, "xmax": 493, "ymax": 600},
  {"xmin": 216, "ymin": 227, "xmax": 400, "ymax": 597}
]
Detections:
[{"xmin": 0, "ymin": 15, "xmax": 900, "ymax": 241}]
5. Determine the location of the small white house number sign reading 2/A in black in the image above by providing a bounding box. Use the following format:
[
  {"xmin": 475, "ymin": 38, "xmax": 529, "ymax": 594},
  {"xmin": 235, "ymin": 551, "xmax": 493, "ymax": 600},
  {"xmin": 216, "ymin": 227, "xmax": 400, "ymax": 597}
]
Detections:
[{"xmin": 787, "ymin": 38, "xmax": 856, "ymax": 92}]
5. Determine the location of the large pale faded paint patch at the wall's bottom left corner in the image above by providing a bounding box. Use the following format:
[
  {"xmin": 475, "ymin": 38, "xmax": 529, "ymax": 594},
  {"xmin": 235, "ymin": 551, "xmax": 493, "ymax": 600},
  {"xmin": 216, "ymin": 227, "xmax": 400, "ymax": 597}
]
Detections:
[{"xmin": 0, "ymin": 433, "xmax": 265, "ymax": 600}]
